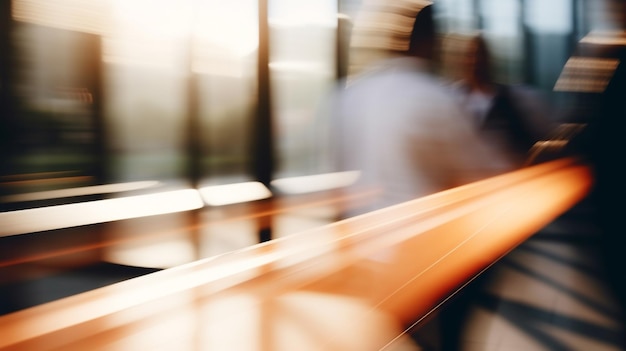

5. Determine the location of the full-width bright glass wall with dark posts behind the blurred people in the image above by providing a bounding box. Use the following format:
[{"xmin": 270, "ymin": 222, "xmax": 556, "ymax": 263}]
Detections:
[{"xmin": 0, "ymin": 0, "xmax": 596, "ymax": 266}]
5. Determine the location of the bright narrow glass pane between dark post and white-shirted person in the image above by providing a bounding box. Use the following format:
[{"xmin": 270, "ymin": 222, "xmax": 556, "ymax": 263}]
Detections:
[{"xmin": 269, "ymin": 0, "xmax": 338, "ymax": 178}]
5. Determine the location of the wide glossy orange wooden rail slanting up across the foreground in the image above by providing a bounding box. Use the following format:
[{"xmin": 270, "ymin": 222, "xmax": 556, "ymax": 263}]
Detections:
[{"xmin": 0, "ymin": 159, "xmax": 592, "ymax": 350}]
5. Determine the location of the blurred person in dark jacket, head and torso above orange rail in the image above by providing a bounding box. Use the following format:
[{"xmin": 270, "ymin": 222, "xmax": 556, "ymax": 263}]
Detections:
[{"xmin": 442, "ymin": 34, "xmax": 555, "ymax": 167}]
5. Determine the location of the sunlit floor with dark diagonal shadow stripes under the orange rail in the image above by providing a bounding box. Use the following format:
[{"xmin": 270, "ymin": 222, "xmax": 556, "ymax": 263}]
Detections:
[{"xmin": 448, "ymin": 198, "xmax": 625, "ymax": 351}]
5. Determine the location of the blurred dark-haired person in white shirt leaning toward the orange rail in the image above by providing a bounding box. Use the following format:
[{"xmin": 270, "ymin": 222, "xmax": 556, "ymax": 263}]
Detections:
[{"xmin": 328, "ymin": 0, "xmax": 513, "ymax": 217}]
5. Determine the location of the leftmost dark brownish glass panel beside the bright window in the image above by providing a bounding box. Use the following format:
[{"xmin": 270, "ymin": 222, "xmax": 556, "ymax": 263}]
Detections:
[{"xmin": 0, "ymin": 1, "xmax": 108, "ymax": 202}]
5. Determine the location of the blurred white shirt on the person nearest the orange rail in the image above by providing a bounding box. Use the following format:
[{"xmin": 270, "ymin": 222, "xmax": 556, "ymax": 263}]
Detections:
[{"xmin": 331, "ymin": 57, "xmax": 512, "ymax": 216}]
